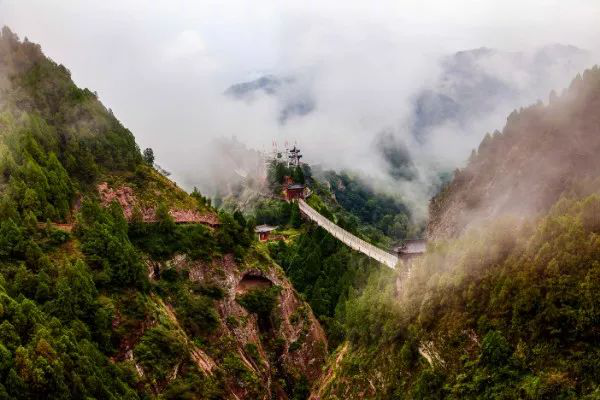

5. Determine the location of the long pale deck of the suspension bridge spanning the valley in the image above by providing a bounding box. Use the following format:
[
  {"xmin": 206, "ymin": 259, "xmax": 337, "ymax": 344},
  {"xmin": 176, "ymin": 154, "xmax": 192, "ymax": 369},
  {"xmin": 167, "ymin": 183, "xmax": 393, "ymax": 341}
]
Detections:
[{"xmin": 298, "ymin": 199, "xmax": 398, "ymax": 268}]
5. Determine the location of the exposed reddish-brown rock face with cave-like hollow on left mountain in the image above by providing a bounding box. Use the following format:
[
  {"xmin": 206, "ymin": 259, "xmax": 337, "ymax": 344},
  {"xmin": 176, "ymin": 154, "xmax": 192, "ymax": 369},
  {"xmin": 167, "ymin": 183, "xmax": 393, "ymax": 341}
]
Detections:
[{"xmin": 162, "ymin": 256, "xmax": 327, "ymax": 399}]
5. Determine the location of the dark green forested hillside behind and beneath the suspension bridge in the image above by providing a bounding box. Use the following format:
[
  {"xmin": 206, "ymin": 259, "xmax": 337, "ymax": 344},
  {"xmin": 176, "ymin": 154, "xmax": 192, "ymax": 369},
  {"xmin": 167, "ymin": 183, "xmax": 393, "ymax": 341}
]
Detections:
[{"xmin": 239, "ymin": 161, "xmax": 421, "ymax": 346}]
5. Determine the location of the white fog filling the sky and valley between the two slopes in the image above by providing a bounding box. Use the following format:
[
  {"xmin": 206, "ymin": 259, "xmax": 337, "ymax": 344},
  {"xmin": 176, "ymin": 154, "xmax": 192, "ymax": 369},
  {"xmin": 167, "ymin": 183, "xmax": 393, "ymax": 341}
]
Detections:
[{"xmin": 0, "ymin": 0, "xmax": 600, "ymax": 219}]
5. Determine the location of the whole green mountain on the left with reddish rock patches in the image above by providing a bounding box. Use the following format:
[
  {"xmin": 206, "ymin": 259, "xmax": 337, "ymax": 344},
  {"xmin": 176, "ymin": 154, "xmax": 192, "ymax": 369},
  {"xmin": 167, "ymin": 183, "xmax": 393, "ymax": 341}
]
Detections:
[{"xmin": 0, "ymin": 28, "xmax": 328, "ymax": 399}]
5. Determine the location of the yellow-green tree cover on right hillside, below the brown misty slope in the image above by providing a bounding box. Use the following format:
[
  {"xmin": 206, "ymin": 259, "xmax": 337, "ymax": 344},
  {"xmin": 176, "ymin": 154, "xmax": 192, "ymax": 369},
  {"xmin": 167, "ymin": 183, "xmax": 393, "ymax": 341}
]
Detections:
[{"xmin": 330, "ymin": 195, "xmax": 600, "ymax": 399}]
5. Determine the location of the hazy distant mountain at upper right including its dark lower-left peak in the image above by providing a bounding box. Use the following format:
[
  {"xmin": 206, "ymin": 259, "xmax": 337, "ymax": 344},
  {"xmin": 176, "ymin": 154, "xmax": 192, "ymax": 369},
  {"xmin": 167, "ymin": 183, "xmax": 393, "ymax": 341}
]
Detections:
[{"xmin": 375, "ymin": 44, "xmax": 591, "ymax": 188}]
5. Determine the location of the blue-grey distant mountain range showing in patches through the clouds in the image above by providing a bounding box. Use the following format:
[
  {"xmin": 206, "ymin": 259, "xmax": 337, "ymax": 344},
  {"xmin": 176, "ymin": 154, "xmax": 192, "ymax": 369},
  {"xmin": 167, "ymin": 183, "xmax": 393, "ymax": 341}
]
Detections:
[{"xmin": 225, "ymin": 44, "xmax": 592, "ymax": 194}]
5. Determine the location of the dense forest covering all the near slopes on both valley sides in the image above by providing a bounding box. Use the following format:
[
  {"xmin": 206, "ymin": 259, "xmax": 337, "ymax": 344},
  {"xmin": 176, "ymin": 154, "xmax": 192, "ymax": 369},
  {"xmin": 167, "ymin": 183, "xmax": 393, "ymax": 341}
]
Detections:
[{"xmin": 0, "ymin": 24, "xmax": 600, "ymax": 400}]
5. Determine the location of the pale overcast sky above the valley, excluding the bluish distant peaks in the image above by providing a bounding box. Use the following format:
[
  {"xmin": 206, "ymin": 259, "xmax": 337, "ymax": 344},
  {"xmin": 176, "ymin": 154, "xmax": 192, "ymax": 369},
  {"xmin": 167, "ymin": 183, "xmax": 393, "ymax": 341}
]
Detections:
[{"xmin": 0, "ymin": 0, "xmax": 600, "ymax": 208}]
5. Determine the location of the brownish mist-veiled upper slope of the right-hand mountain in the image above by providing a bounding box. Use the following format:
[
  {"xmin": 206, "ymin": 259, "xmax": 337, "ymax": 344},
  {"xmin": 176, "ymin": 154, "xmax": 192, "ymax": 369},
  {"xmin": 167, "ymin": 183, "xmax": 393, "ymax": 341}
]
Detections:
[{"xmin": 429, "ymin": 67, "xmax": 600, "ymax": 237}]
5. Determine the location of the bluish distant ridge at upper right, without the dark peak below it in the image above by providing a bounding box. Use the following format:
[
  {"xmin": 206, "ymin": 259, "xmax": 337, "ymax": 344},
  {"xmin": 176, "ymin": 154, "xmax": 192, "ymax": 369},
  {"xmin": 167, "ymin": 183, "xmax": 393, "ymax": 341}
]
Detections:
[{"xmin": 413, "ymin": 44, "xmax": 590, "ymax": 140}]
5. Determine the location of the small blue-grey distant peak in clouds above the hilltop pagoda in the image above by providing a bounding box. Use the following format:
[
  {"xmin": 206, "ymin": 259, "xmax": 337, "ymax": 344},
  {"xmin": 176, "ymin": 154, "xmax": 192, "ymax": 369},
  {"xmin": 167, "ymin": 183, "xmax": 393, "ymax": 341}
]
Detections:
[{"xmin": 225, "ymin": 75, "xmax": 316, "ymax": 124}]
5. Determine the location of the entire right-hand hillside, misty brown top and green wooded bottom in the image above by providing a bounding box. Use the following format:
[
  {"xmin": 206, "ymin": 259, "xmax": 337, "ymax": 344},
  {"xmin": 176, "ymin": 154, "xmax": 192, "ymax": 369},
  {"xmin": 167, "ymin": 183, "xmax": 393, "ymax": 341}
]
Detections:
[{"xmin": 312, "ymin": 68, "xmax": 600, "ymax": 399}]
